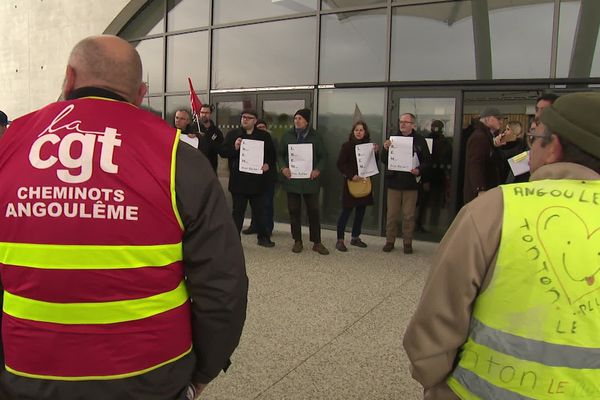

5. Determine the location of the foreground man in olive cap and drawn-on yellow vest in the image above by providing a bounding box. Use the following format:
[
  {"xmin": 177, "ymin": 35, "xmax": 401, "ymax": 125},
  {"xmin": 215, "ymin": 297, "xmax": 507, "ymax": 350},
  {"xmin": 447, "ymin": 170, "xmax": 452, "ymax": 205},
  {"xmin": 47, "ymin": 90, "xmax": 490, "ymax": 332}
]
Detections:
[{"xmin": 404, "ymin": 93, "xmax": 600, "ymax": 400}]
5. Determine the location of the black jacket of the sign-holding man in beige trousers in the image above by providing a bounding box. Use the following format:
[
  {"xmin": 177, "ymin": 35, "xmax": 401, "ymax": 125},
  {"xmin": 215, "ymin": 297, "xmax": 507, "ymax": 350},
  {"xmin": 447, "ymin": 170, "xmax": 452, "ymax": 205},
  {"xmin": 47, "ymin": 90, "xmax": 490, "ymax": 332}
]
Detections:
[{"xmin": 381, "ymin": 130, "xmax": 431, "ymax": 190}]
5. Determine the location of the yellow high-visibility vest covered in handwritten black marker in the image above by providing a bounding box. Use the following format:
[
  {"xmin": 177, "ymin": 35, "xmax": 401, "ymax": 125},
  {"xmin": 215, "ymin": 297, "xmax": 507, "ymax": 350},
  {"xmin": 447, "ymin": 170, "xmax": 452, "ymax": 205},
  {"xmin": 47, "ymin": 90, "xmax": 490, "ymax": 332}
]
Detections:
[{"xmin": 448, "ymin": 180, "xmax": 600, "ymax": 400}]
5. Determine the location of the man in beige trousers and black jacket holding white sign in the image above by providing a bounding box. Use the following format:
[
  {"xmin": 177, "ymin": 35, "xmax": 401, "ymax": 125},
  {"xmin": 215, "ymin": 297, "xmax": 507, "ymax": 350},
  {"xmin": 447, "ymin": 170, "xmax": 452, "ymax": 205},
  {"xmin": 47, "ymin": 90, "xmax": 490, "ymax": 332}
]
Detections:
[{"xmin": 381, "ymin": 113, "xmax": 431, "ymax": 254}]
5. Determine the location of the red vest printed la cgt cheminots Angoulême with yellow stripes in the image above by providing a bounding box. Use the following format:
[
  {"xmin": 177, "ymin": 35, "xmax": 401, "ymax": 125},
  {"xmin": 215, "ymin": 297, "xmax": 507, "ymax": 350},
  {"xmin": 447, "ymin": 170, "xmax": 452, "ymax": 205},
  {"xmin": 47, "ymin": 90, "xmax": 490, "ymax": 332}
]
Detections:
[{"xmin": 0, "ymin": 97, "xmax": 192, "ymax": 380}]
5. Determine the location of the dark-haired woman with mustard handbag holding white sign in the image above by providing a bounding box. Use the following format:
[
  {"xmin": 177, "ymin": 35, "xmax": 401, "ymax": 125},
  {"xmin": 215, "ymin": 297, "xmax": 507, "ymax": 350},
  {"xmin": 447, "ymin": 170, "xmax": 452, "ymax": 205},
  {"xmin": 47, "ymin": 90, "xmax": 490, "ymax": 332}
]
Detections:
[{"xmin": 335, "ymin": 120, "xmax": 379, "ymax": 251}]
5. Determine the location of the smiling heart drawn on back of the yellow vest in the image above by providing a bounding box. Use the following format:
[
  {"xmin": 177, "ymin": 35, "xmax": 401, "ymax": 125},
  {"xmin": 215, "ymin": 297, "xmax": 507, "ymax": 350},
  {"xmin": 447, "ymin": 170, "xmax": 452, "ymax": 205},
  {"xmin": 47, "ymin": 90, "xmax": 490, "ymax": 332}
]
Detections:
[{"xmin": 537, "ymin": 206, "xmax": 600, "ymax": 304}]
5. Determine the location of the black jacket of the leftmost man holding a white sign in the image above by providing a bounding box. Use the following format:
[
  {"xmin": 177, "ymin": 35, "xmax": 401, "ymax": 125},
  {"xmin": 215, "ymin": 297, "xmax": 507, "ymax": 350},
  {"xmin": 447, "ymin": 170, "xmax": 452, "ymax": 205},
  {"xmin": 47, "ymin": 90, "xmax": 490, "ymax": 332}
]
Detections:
[{"xmin": 221, "ymin": 128, "xmax": 276, "ymax": 195}]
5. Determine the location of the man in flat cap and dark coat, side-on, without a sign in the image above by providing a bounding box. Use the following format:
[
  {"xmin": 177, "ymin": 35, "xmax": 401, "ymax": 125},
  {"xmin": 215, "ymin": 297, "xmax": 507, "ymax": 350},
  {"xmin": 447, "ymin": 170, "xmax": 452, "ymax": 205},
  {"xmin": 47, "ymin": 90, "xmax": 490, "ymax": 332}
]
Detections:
[{"xmin": 463, "ymin": 107, "xmax": 508, "ymax": 204}]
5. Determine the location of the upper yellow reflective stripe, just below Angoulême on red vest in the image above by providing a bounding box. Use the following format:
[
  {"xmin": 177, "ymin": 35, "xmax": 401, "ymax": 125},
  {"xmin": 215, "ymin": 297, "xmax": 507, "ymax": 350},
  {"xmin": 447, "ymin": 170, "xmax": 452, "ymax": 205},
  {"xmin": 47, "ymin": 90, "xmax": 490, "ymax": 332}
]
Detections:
[{"xmin": 0, "ymin": 242, "xmax": 183, "ymax": 269}]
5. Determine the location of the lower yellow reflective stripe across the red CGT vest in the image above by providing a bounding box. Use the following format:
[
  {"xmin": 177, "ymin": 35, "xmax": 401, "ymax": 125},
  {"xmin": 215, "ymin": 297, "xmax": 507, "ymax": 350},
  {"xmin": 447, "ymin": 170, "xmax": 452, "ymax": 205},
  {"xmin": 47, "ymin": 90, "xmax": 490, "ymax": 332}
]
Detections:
[{"xmin": 3, "ymin": 281, "xmax": 189, "ymax": 324}]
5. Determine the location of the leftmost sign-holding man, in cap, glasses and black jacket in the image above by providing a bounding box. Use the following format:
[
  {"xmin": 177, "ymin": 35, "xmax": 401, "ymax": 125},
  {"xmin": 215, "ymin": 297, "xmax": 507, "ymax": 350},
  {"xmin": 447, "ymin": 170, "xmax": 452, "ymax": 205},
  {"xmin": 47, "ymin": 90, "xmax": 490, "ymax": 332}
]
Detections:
[{"xmin": 221, "ymin": 110, "xmax": 276, "ymax": 247}]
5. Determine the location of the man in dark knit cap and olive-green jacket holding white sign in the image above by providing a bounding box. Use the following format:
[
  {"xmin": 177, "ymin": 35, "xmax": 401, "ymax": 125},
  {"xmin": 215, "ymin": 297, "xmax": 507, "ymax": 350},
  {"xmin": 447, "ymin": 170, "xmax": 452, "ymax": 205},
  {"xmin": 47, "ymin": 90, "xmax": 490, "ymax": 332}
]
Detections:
[{"xmin": 277, "ymin": 108, "xmax": 329, "ymax": 255}]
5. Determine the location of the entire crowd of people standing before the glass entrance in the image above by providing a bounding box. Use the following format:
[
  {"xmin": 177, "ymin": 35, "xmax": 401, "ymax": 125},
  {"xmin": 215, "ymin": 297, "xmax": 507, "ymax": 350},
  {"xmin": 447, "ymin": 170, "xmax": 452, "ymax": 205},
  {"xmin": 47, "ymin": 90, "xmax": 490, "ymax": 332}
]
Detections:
[{"xmin": 175, "ymin": 94, "xmax": 557, "ymax": 255}]
